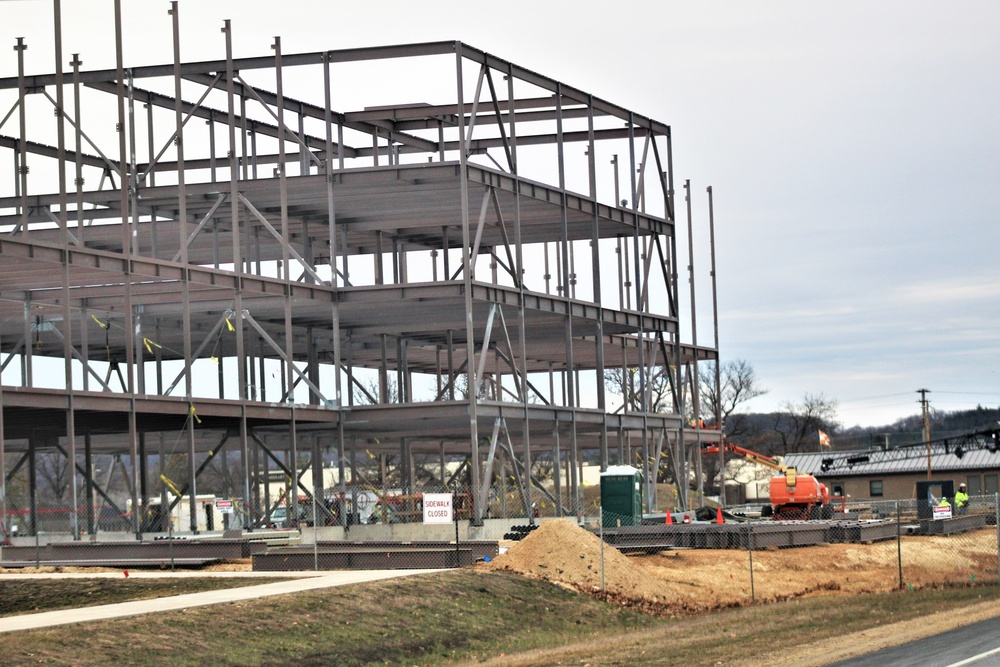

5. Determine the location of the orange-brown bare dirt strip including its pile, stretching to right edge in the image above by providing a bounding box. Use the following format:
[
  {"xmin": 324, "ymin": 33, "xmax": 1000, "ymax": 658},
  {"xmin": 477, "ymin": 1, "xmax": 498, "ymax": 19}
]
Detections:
[{"xmin": 486, "ymin": 519, "xmax": 997, "ymax": 615}]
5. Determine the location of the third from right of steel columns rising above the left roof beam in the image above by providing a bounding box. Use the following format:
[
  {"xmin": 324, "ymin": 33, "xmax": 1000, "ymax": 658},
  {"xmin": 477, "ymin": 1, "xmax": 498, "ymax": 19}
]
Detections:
[{"xmin": 168, "ymin": 0, "xmax": 198, "ymax": 533}]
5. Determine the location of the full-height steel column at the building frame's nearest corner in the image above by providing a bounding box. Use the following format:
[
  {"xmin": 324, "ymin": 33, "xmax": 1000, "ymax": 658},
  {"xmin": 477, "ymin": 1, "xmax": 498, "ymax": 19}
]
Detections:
[{"xmin": 455, "ymin": 42, "xmax": 485, "ymax": 525}]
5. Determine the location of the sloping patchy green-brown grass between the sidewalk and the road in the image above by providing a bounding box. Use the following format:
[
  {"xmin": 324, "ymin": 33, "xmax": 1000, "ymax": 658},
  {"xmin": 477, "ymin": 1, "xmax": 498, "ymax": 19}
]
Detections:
[{"xmin": 2, "ymin": 569, "xmax": 1000, "ymax": 667}]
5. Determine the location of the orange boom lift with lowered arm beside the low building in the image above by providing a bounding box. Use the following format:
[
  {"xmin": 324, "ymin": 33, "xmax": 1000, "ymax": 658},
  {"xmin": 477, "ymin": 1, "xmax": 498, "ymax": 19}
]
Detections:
[{"xmin": 701, "ymin": 440, "xmax": 833, "ymax": 521}]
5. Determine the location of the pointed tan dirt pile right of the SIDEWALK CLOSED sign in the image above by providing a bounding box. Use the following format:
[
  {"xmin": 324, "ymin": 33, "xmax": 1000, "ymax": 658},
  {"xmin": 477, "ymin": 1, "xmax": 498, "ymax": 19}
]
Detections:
[{"xmin": 486, "ymin": 519, "xmax": 675, "ymax": 603}]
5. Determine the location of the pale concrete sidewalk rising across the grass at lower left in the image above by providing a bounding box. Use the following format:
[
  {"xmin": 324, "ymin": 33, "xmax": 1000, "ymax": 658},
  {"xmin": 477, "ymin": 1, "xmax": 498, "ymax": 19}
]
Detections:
[{"xmin": 0, "ymin": 570, "xmax": 441, "ymax": 633}]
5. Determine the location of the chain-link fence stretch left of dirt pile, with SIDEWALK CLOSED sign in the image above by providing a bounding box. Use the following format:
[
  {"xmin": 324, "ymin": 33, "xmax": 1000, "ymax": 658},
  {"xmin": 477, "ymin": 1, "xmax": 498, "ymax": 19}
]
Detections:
[{"xmin": 0, "ymin": 485, "xmax": 540, "ymax": 570}]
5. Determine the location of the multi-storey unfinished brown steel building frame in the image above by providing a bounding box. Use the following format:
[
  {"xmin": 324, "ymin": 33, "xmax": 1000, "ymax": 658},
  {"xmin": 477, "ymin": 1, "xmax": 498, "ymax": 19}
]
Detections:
[{"xmin": 0, "ymin": 0, "xmax": 718, "ymax": 536}]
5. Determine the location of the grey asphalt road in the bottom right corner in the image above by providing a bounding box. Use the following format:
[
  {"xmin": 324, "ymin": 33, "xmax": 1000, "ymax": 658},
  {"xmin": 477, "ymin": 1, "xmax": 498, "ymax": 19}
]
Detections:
[{"xmin": 828, "ymin": 611, "xmax": 1000, "ymax": 667}]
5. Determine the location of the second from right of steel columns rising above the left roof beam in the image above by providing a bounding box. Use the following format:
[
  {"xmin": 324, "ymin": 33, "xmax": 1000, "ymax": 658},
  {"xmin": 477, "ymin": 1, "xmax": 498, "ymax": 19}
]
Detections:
[{"xmin": 222, "ymin": 19, "xmax": 253, "ymax": 530}]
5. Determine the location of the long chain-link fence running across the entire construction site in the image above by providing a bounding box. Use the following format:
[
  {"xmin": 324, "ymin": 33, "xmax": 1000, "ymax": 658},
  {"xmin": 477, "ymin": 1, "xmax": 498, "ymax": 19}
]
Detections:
[{"xmin": 0, "ymin": 478, "xmax": 1000, "ymax": 600}]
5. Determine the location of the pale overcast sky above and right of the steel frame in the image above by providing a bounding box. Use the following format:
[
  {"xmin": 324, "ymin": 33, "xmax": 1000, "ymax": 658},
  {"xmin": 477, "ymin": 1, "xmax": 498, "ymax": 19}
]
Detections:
[{"xmin": 0, "ymin": 0, "xmax": 1000, "ymax": 426}]
